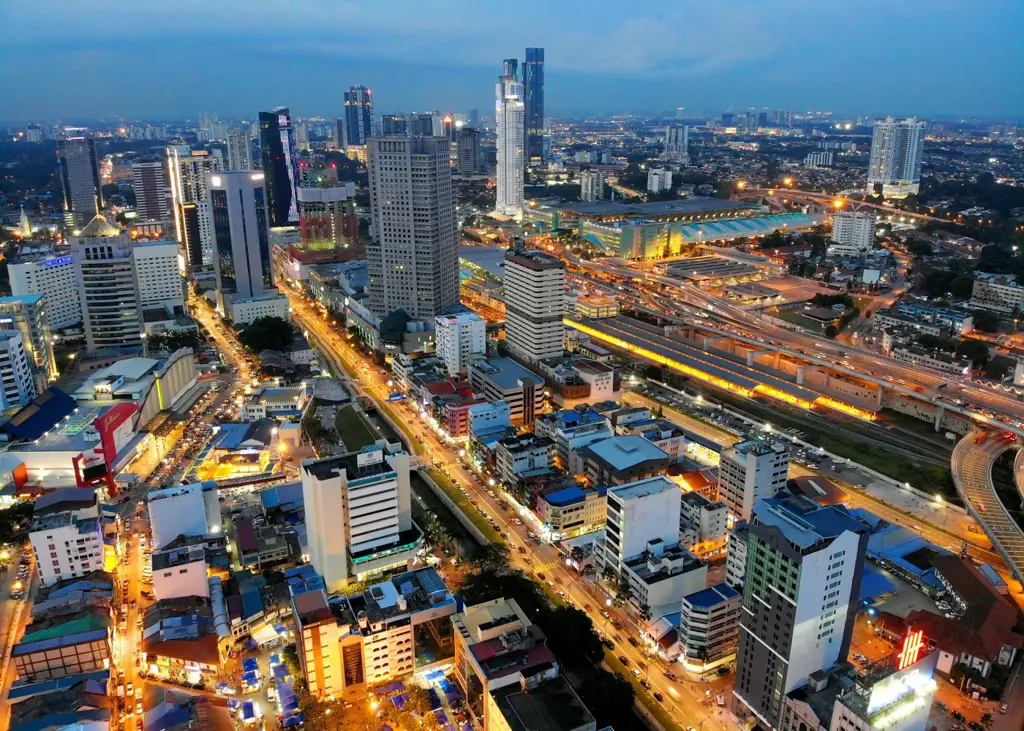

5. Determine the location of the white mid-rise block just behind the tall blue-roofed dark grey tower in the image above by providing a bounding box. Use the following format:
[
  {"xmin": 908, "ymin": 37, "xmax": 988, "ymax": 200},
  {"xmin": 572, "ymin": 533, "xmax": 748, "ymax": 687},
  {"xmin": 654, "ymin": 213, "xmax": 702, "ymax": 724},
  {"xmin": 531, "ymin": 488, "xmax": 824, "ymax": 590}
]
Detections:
[{"xmin": 718, "ymin": 439, "xmax": 790, "ymax": 521}]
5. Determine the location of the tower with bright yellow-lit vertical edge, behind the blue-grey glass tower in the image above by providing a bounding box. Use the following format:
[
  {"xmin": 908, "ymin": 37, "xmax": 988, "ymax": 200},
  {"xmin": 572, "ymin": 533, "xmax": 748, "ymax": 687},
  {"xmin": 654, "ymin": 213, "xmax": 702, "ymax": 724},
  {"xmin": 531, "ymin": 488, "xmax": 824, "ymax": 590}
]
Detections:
[{"xmin": 167, "ymin": 145, "xmax": 221, "ymax": 271}]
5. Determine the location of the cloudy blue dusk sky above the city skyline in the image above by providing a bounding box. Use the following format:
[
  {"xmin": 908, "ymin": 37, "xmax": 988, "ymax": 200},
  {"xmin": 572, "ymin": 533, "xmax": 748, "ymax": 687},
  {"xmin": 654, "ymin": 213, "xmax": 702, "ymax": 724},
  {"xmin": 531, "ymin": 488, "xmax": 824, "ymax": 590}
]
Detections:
[{"xmin": 0, "ymin": 0, "xmax": 1024, "ymax": 122}]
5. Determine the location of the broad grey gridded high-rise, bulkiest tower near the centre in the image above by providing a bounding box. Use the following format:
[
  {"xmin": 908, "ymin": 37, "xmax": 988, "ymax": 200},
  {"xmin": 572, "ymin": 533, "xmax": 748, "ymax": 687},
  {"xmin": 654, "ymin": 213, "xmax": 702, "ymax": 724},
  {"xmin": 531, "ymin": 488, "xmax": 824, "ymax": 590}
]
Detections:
[{"xmin": 367, "ymin": 137, "xmax": 459, "ymax": 321}]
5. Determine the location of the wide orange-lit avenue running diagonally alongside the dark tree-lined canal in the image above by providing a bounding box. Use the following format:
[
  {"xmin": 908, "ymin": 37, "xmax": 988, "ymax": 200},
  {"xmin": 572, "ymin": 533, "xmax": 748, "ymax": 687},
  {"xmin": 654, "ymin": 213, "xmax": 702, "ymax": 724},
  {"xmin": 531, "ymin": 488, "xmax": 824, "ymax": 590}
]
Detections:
[{"xmin": 282, "ymin": 287, "xmax": 736, "ymax": 731}]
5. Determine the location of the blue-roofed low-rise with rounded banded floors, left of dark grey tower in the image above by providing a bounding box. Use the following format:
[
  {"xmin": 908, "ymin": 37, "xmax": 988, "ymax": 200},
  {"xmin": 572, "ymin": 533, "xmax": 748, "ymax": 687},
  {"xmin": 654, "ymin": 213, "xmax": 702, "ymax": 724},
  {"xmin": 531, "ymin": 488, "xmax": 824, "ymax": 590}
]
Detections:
[{"xmin": 679, "ymin": 584, "xmax": 742, "ymax": 676}]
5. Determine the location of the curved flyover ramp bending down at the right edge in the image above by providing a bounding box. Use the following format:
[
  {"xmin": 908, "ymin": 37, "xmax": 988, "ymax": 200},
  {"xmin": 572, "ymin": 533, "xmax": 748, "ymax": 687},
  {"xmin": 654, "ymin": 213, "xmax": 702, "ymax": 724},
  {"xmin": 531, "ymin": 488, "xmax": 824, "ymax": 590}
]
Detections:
[{"xmin": 952, "ymin": 431, "xmax": 1024, "ymax": 583}]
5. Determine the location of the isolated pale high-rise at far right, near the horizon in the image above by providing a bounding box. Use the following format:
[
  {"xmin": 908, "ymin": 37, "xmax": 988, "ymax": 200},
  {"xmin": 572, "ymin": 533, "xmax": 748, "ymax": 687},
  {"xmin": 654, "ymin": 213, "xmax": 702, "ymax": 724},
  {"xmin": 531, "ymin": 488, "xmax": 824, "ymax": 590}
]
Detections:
[{"xmin": 867, "ymin": 117, "xmax": 925, "ymax": 198}]
